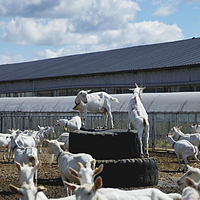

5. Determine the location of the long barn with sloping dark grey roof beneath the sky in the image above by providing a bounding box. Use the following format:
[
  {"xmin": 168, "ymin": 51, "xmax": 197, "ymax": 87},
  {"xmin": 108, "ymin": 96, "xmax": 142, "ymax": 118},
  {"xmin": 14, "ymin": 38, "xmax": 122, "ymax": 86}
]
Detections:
[{"xmin": 0, "ymin": 38, "xmax": 200, "ymax": 97}]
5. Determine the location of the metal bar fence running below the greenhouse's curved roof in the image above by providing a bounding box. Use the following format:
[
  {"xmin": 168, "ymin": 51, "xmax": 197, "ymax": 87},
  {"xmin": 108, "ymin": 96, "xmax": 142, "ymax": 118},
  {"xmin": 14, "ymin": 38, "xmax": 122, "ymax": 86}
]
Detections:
[{"xmin": 0, "ymin": 112, "xmax": 200, "ymax": 149}]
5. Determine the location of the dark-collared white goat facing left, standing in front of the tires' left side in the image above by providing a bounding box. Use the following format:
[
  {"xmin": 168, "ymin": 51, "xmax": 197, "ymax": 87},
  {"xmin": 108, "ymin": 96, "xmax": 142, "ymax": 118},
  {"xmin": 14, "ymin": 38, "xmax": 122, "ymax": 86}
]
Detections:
[{"xmin": 46, "ymin": 140, "xmax": 96, "ymax": 195}]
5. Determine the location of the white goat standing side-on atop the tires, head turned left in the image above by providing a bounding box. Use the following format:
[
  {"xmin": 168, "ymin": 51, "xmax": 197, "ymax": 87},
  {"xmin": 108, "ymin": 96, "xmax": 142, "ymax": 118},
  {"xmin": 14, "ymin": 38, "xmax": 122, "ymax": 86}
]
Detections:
[{"xmin": 73, "ymin": 90, "xmax": 119, "ymax": 128}]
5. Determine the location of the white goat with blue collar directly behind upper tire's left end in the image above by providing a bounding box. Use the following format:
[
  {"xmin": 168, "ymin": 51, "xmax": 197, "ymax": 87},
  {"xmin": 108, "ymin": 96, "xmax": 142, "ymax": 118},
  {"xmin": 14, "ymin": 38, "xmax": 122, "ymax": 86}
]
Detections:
[{"xmin": 56, "ymin": 116, "xmax": 81, "ymax": 132}]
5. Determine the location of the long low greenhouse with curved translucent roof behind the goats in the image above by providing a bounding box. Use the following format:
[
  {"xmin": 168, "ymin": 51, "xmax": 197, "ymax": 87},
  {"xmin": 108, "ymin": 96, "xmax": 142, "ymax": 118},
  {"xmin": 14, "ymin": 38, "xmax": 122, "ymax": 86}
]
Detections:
[{"xmin": 0, "ymin": 92, "xmax": 200, "ymax": 148}]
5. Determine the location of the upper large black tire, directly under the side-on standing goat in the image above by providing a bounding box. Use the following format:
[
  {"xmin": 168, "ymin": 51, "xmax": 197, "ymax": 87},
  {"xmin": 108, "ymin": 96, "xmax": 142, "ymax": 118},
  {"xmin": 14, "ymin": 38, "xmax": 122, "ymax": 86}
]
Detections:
[{"xmin": 69, "ymin": 130, "xmax": 140, "ymax": 160}]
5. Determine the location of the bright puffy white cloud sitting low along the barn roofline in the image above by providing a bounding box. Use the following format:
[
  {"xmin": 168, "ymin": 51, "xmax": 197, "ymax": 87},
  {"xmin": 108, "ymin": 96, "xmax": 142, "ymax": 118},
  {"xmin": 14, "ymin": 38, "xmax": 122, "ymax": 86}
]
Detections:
[{"xmin": 36, "ymin": 21, "xmax": 184, "ymax": 59}]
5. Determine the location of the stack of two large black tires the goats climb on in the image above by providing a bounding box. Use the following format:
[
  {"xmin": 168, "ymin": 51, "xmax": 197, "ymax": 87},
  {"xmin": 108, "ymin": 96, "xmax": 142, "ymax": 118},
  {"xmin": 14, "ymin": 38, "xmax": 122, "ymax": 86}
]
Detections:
[{"xmin": 69, "ymin": 130, "xmax": 158, "ymax": 188}]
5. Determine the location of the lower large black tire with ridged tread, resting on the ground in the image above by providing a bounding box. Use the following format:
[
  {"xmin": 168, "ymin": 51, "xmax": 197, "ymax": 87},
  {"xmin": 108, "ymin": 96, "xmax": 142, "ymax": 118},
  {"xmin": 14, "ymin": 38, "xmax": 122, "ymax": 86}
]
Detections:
[{"xmin": 97, "ymin": 158, "xmax": 158, "ymax": 188}]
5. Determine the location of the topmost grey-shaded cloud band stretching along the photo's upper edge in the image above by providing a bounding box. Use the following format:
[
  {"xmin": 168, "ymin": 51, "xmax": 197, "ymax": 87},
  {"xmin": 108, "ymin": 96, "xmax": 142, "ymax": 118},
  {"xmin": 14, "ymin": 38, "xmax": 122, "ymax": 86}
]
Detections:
[{"xmin": 0, "ymin": 0, "xmax": 140, "ymax": 24}]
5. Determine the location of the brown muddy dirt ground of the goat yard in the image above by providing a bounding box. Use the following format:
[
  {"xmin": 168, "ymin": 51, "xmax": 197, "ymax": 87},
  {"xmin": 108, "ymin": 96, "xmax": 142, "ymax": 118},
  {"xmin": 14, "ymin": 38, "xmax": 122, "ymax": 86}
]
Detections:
[{"xmin": 0, "ymin": 148, "xmax": 195, "ymax": 200}]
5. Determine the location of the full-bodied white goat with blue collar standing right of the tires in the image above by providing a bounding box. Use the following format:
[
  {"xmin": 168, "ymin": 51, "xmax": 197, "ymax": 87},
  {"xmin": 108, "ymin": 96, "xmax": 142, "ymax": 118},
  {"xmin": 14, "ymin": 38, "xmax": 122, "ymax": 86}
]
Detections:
[{"xmin": 167, "ymin": 134, "xmax": 200, "ymax": 170}]
